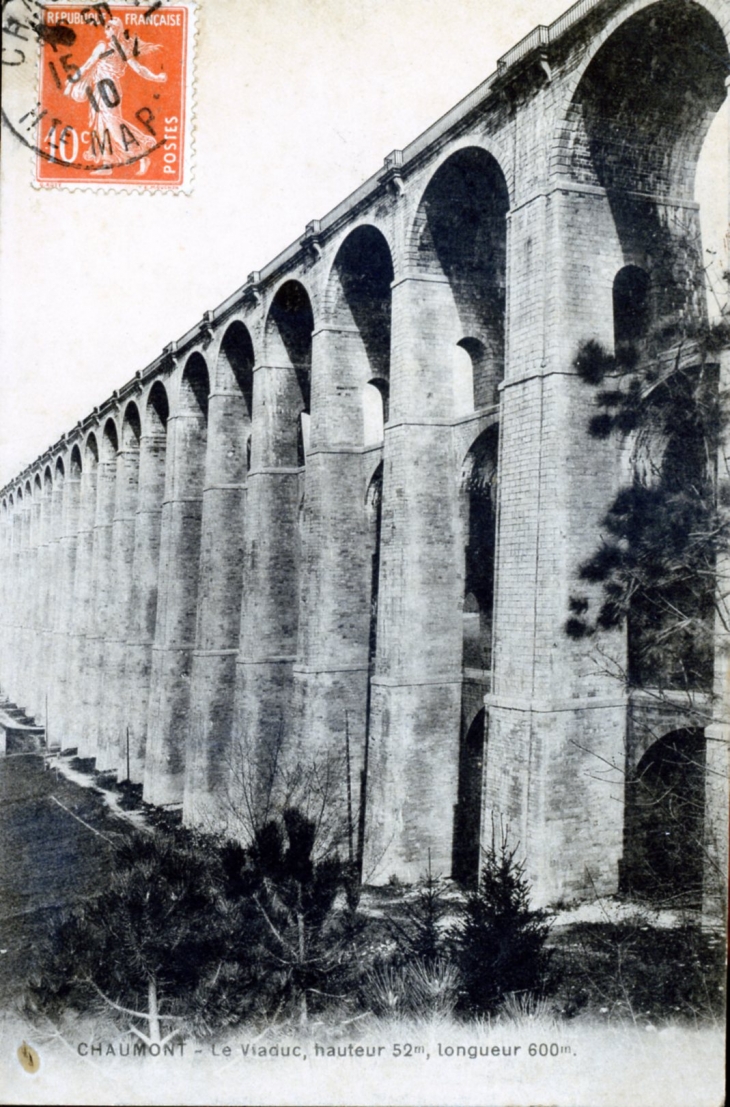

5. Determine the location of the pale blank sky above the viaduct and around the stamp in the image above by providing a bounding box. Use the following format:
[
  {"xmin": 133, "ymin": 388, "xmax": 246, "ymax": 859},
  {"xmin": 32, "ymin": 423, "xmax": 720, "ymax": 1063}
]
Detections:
[{"xmin": 0, "ymin": 0, "xmax": 730, "ymax": 487}]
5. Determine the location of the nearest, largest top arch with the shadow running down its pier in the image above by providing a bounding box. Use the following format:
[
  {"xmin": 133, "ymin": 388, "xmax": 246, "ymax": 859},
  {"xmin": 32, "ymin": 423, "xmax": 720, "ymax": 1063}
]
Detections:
[{"xmin": 555, "ymin": 0, "xmax": 730, "ymax": 342}]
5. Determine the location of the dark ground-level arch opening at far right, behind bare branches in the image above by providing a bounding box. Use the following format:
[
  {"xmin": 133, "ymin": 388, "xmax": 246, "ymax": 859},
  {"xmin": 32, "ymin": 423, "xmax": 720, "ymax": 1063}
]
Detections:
[{"xmin": 621, "ymin": 727, "xmax": 706, "ymax": 907}]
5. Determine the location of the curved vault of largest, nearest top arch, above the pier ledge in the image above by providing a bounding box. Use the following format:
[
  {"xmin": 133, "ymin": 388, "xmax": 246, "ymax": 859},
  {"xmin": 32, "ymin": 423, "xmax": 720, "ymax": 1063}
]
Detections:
[{"xmin": 556, "ymin": 0, "xmax": 730, "ymax": 200}]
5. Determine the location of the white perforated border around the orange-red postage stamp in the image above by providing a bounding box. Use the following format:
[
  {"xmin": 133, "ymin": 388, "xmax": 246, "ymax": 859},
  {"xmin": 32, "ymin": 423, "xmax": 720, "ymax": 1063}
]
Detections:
[{"xmin": 28, "ymin": 0, "xmax": 198, "ymax": 196}]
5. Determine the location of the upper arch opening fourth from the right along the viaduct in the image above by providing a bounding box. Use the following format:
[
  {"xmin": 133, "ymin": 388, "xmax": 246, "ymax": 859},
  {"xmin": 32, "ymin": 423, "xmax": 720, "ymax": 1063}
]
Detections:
[{"xmin": 265, "ymin": 280, "xmax": 315, "ymax": 467}]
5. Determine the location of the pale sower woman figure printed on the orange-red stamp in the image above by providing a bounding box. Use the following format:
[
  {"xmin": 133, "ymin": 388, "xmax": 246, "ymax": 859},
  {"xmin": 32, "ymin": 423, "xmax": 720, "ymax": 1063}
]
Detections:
[{"xmin": 63, "ymin": 18, "xmax": 167, "ymax": 176}]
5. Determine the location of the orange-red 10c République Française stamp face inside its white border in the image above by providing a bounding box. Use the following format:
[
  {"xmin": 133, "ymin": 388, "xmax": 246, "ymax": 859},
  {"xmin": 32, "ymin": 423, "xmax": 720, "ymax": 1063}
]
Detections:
[{"xmin": 35, "ymin": 3, "xmax": 193, "ymax": 188}]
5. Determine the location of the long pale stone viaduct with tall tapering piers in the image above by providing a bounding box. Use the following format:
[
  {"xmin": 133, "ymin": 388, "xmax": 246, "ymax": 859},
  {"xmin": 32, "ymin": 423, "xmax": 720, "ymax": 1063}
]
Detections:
[{"xmin": 0, "ymin": 0, "xmax": 730, "ymax": 902}]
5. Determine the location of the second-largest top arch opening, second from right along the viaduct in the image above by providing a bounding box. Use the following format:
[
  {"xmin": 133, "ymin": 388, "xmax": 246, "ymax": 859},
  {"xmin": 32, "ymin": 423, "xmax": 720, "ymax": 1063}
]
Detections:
[{"xmin": 409, "ymin": 146, "xmax": 510, "ymax": 414}]
